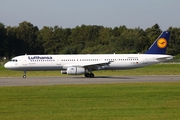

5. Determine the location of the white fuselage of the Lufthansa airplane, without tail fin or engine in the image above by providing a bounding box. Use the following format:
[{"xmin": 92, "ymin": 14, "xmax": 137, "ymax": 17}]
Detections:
[{"xmin": 4, "ymin": 54, "xmax": 173, "ymax": 71}]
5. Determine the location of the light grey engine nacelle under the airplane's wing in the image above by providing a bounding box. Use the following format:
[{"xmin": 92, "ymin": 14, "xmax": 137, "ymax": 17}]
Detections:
[{"xmin": 61, "ymin": 67, "xmax": 85, "ymax": 75}]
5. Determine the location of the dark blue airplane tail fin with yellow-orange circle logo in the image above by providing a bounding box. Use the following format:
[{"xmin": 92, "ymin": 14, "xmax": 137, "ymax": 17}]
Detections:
[{"xmin": 145, "ymin": 31, "xmax": 170, "ymax": 54}]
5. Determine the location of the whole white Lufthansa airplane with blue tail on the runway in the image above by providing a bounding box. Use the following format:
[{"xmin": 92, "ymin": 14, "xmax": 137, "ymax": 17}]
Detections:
[{"xmin": 4, "ymin": 31, "xmax": 173, "ymax": 78}]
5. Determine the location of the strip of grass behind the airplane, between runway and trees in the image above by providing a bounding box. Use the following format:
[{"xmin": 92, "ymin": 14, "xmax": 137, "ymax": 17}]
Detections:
[{"xmin": 0, "ymin": 64, "xmax": 180, "ymax": 77}]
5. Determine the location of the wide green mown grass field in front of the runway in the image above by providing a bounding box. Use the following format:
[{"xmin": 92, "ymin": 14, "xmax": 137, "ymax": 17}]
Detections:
[{"xmin": 0, "ymin": 82, "xmax": 180, "ymax": 120}]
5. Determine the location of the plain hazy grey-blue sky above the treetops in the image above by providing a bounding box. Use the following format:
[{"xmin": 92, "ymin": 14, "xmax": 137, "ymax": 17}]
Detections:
[{"xmin": 0, "ymin": 0, "xmax": 180, "ymax": 30}]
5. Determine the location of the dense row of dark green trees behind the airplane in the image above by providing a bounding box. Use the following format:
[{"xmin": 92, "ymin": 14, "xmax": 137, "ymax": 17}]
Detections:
[{"xmin": 0, "ymin": 21, "xmax": 180, "ymax": 59}]
